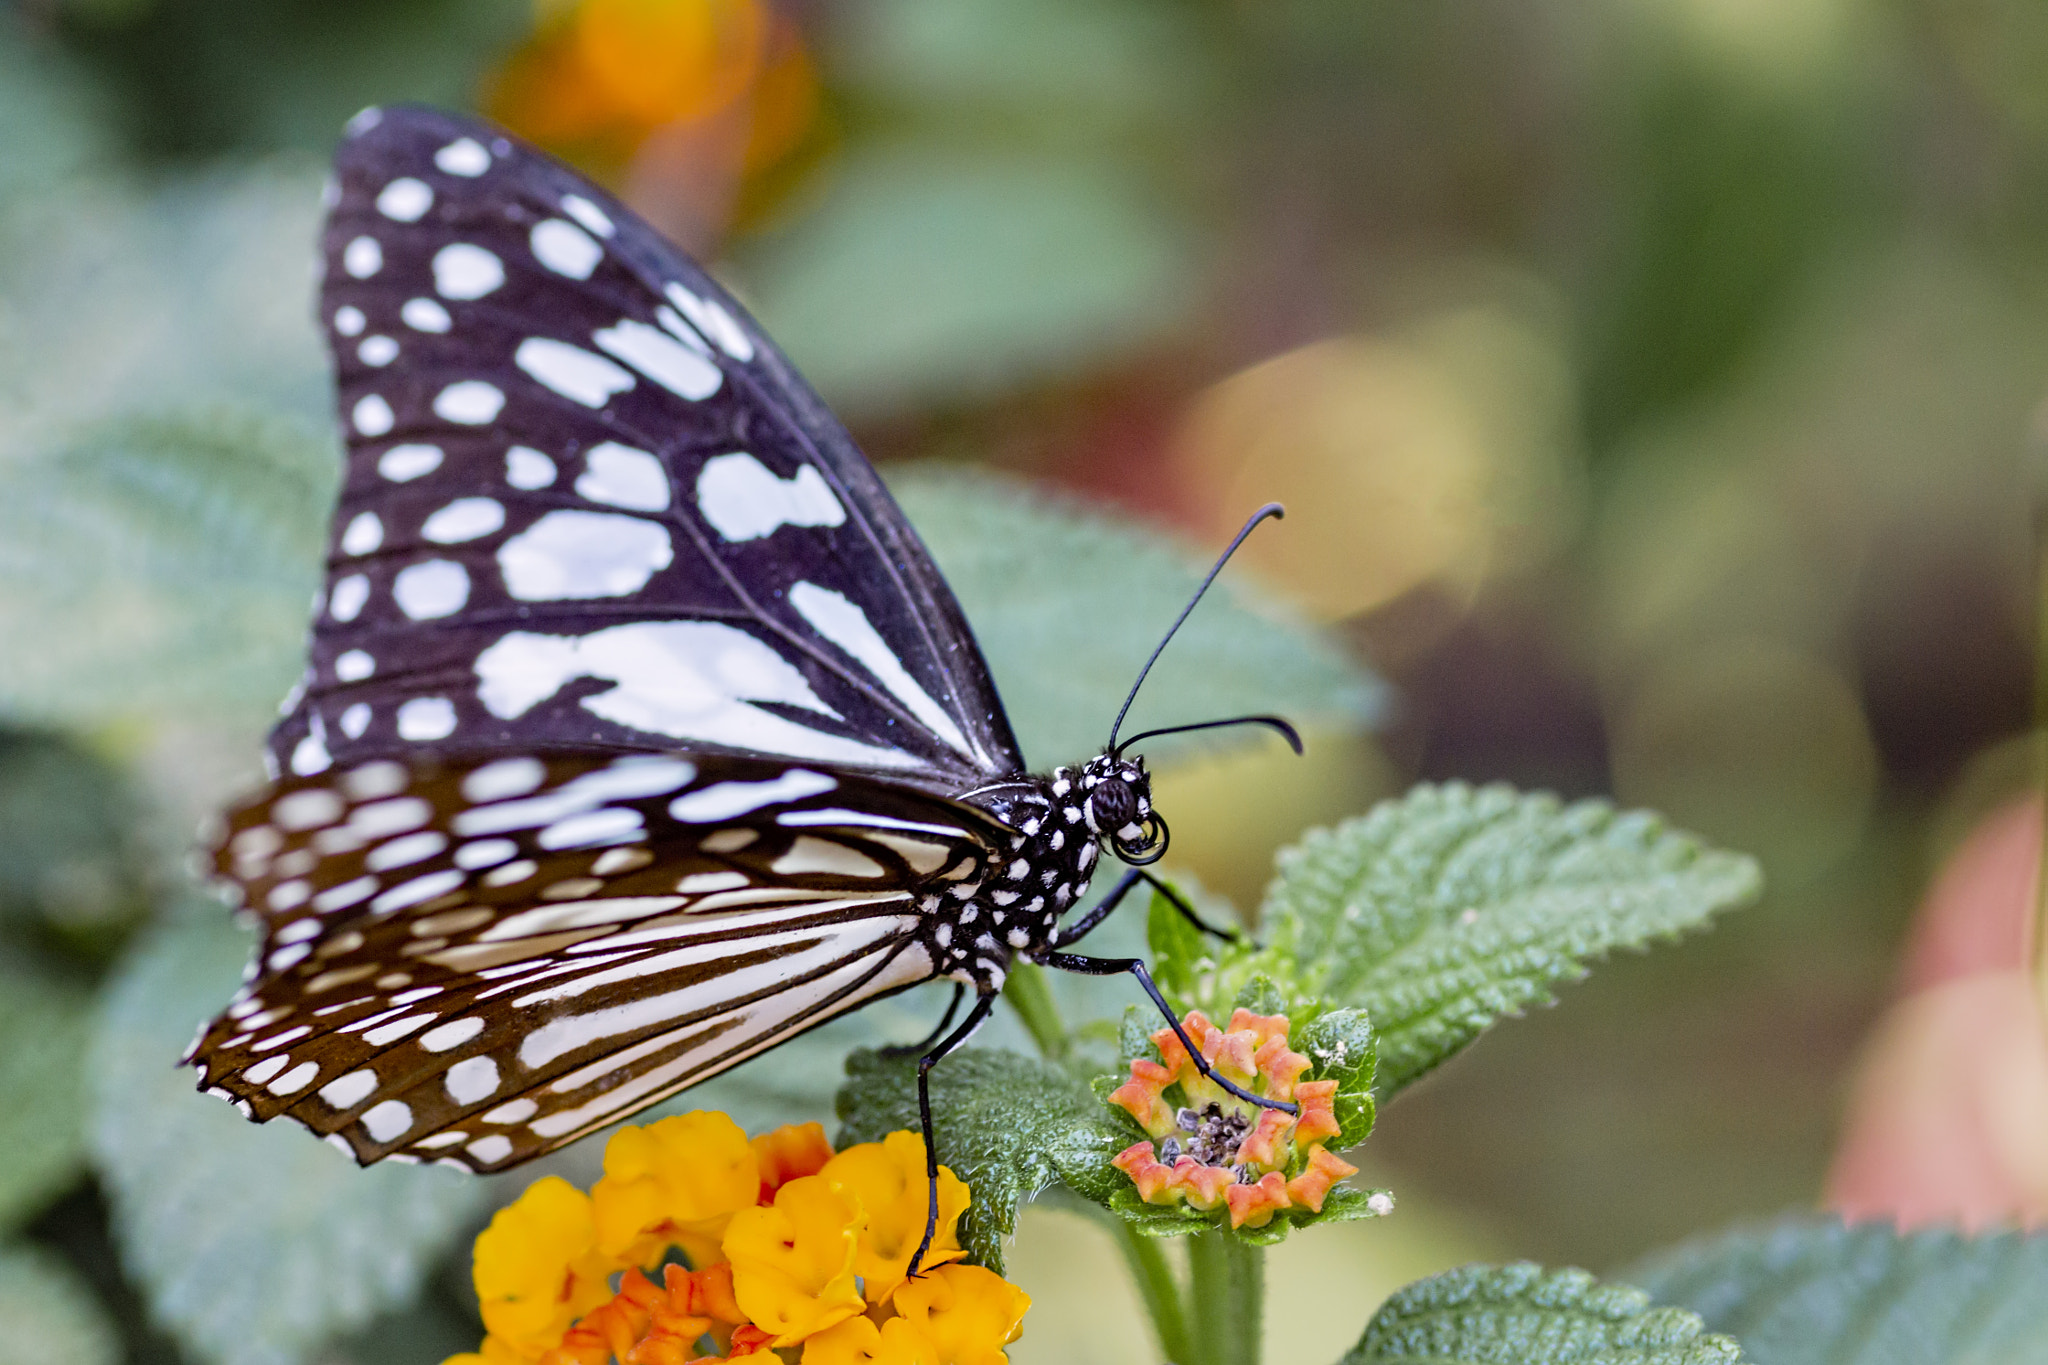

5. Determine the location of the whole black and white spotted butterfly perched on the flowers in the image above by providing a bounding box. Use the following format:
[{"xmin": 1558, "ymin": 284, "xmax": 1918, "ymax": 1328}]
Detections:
[{"xmin": 188, "ymin": 108, "xmax": 1292, "ymax": 1260}]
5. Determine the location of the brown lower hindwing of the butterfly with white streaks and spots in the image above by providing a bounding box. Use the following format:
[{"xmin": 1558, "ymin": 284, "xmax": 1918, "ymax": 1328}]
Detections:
[{"xmin": 195, "ymin": 753, "xmax": 1008, "ymax": 1171}]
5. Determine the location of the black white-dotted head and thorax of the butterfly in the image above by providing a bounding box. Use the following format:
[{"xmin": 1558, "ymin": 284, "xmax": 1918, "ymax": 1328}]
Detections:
[{"xmin": 918, "ymin": 753, "xmax": 1163, "ymax": 990}]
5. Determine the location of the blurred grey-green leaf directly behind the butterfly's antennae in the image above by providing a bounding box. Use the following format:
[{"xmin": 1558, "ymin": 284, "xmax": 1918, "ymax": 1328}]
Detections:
[{"xmin": 891, "ymin": 465, "xmax": 1384, "ymax": 763}]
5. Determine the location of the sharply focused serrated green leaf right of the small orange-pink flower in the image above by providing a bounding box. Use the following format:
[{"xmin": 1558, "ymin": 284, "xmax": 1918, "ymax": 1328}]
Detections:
[{"xmin": 1260, "ymin": 784, "xmax": 1761, "ymax": 1101}]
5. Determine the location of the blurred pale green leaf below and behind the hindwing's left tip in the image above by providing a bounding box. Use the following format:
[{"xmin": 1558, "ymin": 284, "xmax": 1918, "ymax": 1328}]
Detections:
[{"xmin": 90, "ymin": 902, "xmax": 487, "ymax": 1365}]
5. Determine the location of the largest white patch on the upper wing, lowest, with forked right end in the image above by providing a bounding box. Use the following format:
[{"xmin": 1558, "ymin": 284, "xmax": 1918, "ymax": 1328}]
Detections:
[{"xmin": 475, "ymin": 620, "xmax": 918, "ymax": 767}]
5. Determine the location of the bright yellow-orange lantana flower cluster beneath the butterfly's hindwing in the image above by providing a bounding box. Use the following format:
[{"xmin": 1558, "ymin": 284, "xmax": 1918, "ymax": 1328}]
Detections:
[{"xmin": 446, "ymin": 1111, "xmax": 1030, "ymax": 1365}]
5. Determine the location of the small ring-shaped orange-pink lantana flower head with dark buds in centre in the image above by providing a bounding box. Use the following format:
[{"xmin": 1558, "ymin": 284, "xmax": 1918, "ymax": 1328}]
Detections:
[{"xmin": 1108, "ymin": 1009, "xmax": 1358, "ymax": 1228}]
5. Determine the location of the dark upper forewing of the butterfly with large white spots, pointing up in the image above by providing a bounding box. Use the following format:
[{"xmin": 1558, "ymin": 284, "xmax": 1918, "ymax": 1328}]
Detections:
[{"xmin": 284, "ymin": 108, "xmax": 1022, "ymax": 792}]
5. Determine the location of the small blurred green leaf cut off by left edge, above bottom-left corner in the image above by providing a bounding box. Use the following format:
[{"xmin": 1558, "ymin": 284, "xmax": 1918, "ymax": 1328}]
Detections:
[{"xmin": 0, "ymin": 962, "xmax": 92, "ymax": 1236}]
